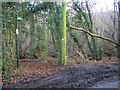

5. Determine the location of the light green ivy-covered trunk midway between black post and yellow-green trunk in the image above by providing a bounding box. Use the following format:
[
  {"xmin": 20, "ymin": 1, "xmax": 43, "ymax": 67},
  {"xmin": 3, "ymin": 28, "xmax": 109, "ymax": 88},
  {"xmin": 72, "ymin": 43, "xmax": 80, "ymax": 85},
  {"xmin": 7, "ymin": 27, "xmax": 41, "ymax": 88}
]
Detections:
[{"xmin": 35, "ymin": 14, "xmax": 48, "ymax": 61}]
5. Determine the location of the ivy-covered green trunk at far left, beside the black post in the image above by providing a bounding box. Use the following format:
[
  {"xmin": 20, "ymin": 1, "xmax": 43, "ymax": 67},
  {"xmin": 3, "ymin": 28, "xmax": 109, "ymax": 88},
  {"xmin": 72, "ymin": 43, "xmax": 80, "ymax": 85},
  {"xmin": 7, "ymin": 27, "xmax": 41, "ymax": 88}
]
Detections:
[{"xmin": 1, "ymin": 2, "xmax": 16, "ymax": 81}]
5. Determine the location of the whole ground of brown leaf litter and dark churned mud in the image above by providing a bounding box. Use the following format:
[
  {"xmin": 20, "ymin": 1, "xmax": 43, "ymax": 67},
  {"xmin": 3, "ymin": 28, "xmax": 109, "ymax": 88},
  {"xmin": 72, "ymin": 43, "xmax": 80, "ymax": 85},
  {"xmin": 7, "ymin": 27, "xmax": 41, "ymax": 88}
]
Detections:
[{"xmin": 3, "ymin": 57, "xmax": 119, "ymax": 88}]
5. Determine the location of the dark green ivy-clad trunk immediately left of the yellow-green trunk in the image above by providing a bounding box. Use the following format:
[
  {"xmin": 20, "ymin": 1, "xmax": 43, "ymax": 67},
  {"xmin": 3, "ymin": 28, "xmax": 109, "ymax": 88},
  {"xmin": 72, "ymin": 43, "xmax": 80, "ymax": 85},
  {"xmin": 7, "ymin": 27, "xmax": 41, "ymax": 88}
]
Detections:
[{"xmin": 48, "ymin": 3, "xmax": 62, "ymax": 61}]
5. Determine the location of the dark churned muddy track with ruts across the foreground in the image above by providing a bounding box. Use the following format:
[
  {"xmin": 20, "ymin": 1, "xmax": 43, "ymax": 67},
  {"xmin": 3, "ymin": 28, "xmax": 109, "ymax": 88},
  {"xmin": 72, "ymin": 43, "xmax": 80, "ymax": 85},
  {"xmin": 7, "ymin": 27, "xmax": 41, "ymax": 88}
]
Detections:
[{"xmin": 3, "ymin": 57, "xmax": 120, "ymax": 88}]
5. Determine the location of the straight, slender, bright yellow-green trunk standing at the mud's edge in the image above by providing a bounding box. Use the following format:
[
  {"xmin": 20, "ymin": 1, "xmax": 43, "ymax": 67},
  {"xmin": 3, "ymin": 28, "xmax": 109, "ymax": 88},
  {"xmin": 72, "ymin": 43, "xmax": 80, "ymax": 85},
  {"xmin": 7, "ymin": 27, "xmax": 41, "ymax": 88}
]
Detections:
[{"xmin": 61, "ymin": 0, "xmax": 67, "ymax": 65}]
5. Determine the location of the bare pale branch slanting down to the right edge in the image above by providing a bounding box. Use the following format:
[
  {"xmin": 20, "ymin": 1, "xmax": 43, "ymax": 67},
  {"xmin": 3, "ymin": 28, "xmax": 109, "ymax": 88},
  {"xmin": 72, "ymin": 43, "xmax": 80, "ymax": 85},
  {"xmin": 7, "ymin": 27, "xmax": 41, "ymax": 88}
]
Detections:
[{"xmin": 70, "ymin": 25, "xmax": 120, "ymax": 46}]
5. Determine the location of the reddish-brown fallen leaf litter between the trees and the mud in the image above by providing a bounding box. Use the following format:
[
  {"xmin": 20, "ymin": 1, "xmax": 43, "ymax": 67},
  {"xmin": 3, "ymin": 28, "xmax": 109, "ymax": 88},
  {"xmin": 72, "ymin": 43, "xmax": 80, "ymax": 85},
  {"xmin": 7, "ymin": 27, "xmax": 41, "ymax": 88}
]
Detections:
[{"xmin": 3, "ymin": 57, "xmax": 117, "ymax": 83}]
